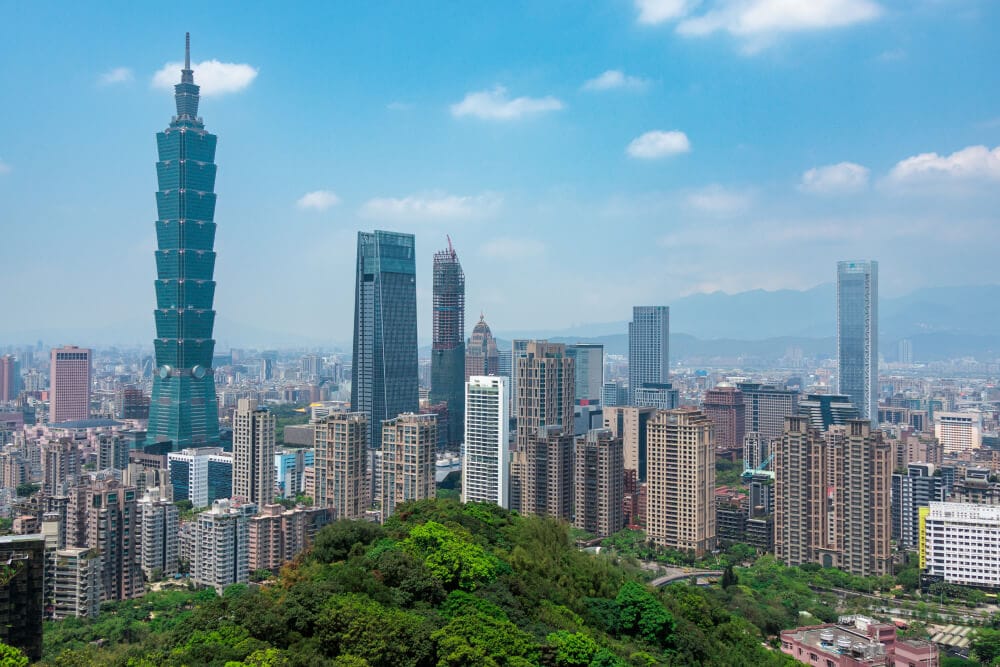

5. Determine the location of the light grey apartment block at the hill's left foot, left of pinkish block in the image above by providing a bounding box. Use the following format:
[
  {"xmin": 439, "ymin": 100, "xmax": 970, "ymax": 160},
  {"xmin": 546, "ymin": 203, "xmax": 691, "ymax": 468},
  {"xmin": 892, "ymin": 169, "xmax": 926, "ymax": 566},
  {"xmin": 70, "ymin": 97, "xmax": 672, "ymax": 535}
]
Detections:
[{"xmin": 191, "ymin": 500, "xmax": 257, "ymax": 593}]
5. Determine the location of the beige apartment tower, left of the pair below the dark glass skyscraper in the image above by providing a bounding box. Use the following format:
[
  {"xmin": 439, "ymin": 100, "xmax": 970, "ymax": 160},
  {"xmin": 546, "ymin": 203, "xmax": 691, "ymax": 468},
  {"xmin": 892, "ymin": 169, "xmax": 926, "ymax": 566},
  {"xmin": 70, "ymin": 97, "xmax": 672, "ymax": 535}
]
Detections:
[{"xmin": 313, "ymin": 412, "xmax": 371, "ymax": 519}]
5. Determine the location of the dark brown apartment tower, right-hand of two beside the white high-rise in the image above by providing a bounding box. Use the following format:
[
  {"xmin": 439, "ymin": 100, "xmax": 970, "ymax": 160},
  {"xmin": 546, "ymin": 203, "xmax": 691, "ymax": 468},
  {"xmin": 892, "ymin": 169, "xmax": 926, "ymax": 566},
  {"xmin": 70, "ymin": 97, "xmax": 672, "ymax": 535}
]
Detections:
[{"xmin": 573, "ymin": 429, "xmax": 625, "ymax": 537}]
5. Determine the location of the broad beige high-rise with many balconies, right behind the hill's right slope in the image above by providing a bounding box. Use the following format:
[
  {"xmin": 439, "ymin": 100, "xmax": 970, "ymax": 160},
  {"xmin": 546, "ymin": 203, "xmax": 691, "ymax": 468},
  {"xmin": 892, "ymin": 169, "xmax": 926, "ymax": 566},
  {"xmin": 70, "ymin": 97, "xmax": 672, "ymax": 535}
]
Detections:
[{"xmin": 646, "ymin": 408, "xmax": 715, "ymax": 557}]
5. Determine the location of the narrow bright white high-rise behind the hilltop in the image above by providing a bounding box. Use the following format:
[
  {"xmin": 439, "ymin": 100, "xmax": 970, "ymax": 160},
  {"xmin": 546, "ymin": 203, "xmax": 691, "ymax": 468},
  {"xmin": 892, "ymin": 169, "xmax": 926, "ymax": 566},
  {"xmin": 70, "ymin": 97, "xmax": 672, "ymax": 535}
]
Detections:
[{"xmin": 462, "ymin": 375, "xmax": 510, "ymax": 508}]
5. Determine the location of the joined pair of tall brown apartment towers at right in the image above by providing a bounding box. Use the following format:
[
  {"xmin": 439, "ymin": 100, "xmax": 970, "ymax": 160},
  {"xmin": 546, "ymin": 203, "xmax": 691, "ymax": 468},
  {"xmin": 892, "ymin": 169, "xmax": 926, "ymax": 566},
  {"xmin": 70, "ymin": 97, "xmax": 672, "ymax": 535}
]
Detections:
[{"xmin": 774, "ymin": 416, "xmax": 893, "ymax": 576}]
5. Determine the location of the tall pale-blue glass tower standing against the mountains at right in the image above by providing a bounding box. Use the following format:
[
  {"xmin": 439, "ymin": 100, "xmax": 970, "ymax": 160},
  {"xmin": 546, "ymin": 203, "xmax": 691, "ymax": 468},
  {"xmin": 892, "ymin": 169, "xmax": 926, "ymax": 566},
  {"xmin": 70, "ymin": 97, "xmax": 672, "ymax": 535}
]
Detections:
[{"xmin": 837, "ymin": 260, "xmax": 878, "ymax": 423}]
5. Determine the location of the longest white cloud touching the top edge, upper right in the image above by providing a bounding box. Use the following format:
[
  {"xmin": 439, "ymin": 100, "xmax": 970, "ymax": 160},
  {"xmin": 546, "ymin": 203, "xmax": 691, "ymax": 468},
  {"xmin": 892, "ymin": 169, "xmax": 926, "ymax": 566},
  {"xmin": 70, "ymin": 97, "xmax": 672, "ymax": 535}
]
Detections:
[{"xmin": 677, "ymin": 0, "xmax": 883, "ymax": 37}]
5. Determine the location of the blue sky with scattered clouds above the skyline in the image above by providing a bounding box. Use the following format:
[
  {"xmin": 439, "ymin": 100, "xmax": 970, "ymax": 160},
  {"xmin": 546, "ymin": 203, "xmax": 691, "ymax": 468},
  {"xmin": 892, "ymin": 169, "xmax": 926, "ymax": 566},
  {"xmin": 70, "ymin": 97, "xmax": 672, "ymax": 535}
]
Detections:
[{"xmin": 0, "ymin": 0, "xmax": 1000, "ymax": 347}]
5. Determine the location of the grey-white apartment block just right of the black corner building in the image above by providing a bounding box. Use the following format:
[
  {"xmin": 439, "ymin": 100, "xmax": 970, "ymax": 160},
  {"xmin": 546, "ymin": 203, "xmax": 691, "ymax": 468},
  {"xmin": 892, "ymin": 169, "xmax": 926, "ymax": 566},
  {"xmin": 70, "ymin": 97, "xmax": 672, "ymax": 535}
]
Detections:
[{"xmin": 45, "ymin": 547, "xmax": 102, "ymax": 621}]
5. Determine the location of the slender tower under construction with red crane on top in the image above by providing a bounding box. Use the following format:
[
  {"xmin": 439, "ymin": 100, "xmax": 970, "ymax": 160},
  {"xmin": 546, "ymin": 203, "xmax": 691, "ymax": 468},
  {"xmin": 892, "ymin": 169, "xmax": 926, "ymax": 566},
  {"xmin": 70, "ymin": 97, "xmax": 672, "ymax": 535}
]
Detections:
[{"xmin": 430, "ymin": 243, "xmax": 466, "ymax": 445}]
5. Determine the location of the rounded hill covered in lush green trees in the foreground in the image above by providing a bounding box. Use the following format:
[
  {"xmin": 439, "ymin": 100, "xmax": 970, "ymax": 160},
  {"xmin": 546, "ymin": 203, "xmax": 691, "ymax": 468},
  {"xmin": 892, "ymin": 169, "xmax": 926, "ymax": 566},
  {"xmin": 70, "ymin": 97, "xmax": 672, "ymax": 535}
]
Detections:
[{"xmin": 45, "ymin": 500, "xmax": 794, "ymax": 667}]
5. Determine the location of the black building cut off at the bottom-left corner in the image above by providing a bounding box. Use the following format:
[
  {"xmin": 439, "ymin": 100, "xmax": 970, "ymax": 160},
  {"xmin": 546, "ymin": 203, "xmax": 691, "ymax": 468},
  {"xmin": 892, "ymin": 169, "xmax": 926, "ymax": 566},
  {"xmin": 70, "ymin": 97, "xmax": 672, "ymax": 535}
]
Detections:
[{"xmin": 0, "ymin": 535, "xmax": 45, "ymax": 662}]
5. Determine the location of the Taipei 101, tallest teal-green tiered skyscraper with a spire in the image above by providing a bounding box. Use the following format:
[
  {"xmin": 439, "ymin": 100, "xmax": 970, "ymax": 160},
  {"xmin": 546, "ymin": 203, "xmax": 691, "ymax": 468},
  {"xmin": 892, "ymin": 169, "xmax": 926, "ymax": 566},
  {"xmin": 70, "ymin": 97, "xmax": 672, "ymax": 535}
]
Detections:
[{"xmin": 147, "ymin": 34, "xmax": 219, "ymax": 451}]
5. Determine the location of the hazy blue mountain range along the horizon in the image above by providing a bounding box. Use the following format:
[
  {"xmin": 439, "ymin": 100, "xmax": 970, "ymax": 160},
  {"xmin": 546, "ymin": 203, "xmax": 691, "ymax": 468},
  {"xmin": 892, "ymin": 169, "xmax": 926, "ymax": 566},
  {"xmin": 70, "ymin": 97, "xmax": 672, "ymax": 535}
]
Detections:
[{"xmin": 7, "ymin": 284, "xmax": 1000, "ymax": 361}]
